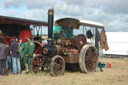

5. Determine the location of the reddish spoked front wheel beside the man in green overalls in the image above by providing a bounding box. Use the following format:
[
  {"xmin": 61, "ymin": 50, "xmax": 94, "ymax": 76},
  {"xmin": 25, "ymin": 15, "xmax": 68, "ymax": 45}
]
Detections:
[{"xmin": 31, "ymin": 55, "xmax": 43, "ymax": 74}]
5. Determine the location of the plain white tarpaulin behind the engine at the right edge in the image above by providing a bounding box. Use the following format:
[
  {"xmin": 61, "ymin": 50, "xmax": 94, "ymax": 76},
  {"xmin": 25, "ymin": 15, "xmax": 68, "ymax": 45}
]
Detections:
[{"xmin": 103, "ymin": 32, "xmax": 128, "ymax": 55}]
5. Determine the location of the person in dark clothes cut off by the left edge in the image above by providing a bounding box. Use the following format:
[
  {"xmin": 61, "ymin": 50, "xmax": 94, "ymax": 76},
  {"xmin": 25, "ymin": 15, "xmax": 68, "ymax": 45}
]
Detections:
[{"xmin": 0, "ymin": 36, "xmax": 8, "ymax": 76}]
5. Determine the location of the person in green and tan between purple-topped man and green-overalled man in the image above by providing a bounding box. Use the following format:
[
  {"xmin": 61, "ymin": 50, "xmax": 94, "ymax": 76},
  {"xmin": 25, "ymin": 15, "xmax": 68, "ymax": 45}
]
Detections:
[{"xmin": 18, "ymin": 38, "xmax": 25, "ymax": 70}]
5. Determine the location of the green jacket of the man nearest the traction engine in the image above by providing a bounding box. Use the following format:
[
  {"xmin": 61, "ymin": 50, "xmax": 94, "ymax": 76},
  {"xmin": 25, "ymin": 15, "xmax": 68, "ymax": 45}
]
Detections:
[{"xmin": 25, "ymin": 41, "xmax": 35, "ymax": 57}]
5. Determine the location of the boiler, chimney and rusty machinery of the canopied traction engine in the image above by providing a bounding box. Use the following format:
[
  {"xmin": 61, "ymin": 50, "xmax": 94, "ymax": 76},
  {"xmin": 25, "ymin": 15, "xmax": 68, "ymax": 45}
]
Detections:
[{"xmin": 42, "ymin": 10, "xmax": 87, "ymax": 57}]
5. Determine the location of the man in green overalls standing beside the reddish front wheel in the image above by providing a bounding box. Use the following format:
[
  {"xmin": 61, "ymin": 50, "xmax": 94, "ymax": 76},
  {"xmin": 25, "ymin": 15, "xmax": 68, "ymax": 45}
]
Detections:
[{"xmin": 24, "ymin": 37, "xmax": 35, "ymax": 73}]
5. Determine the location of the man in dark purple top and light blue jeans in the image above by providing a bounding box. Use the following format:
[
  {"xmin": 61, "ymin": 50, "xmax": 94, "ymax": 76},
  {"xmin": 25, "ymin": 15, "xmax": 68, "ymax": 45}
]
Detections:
[{"xmin": 10, "ymin": 37, "xmax": 21, "ymax": 74}]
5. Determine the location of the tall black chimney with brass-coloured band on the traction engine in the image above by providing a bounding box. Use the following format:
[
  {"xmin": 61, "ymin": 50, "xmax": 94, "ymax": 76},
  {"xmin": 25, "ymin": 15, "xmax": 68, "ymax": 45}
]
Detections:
[{"xmin": 48, "ymin": 9, "xmax": 54, "ymax": 45}]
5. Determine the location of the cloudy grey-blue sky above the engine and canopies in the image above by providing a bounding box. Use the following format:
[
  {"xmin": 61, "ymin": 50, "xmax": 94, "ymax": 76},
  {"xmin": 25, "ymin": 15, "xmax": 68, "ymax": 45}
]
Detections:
[{"xmin": 0, "ymin": 0, "xmax": 128, "ymax": 32}]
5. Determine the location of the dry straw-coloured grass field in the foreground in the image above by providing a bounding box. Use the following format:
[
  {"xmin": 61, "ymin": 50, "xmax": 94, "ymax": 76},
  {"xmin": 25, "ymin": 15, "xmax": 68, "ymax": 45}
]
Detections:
[{"xmin": 0, "ymin": 59, "xmax": 128, "ymax": 85}]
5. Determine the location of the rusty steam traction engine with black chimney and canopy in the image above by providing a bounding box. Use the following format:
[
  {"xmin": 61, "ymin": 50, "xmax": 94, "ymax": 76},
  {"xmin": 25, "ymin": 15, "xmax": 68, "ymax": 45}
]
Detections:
[{"xmin": 32, "ymin": 10, "xmax": 104, "ymax": 76}]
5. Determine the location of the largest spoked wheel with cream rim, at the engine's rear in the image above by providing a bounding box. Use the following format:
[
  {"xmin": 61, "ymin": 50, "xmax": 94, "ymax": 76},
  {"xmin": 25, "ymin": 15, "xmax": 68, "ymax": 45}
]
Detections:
[{"xmin": 79, "ymin": 45, "xmax": 98, "ymax": 73}]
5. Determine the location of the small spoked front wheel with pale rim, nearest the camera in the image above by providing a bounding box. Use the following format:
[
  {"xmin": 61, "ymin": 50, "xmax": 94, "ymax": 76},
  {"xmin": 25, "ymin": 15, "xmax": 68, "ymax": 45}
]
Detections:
[{"xmin": 51, "ymin": 55, "xmax": 65, "ymax": 76}]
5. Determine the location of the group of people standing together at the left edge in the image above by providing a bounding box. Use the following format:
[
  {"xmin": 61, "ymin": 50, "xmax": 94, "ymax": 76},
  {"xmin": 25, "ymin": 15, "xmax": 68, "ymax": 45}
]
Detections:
[{"xmin": 0, "ymin": 36, "xmax": 35, "ymax": 76}]
